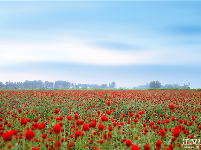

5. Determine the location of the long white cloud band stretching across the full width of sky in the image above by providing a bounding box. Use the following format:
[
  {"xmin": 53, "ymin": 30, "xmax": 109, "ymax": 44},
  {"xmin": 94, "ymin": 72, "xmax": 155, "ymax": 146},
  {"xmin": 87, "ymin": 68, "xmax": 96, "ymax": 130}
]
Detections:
[{"xmin": 0, "ymin": 36, "xmax": 200, "ymax": 66}]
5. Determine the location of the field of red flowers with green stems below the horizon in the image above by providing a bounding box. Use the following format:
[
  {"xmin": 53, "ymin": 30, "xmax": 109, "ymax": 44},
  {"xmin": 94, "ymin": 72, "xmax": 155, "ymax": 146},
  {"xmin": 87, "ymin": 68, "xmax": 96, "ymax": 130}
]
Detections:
[{"xmin": 0, "ymin": 90, "xmax": 201, "ymax": 150}]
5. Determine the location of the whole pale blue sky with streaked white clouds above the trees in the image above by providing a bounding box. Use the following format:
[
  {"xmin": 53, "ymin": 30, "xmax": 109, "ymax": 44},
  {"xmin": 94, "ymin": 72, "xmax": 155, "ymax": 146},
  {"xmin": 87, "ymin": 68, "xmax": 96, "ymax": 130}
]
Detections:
[{"xmin": 0, "ymin": 1, "xmax": 201, "ymax": 88}]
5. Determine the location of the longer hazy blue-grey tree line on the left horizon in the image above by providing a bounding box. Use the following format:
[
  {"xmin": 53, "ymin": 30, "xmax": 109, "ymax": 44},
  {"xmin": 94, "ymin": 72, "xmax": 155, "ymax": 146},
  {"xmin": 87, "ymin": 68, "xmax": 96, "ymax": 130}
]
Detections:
[{"xmin": 0, "ymin": 80, "xmax": 116, "ymax": 89}]
